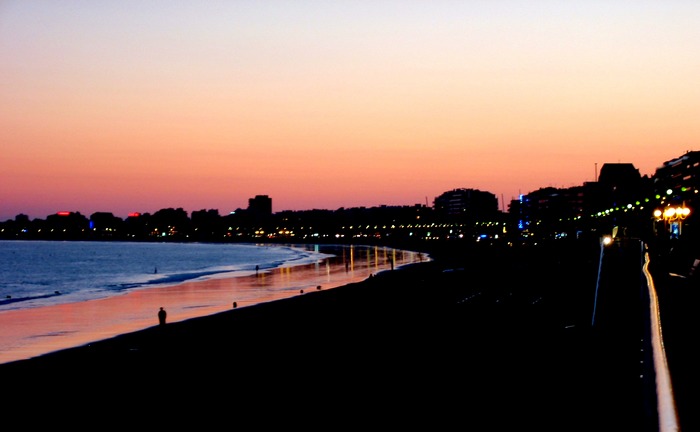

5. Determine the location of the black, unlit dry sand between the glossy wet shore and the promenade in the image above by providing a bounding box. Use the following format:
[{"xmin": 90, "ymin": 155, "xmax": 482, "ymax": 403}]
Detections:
[{"xmin": 0, "ymin": 243, "xmax": 653, "ymax": 431}]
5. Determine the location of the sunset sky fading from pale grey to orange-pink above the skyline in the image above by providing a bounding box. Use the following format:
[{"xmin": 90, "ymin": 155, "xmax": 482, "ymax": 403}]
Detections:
[{"xmin": 0, "ymin": 0, "xmax": 700, "ymax": 221}]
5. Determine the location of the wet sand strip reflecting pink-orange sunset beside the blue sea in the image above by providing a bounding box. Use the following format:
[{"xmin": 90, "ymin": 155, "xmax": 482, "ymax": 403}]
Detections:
[{"xmin": 0, "ymin": 245, "xmax": 425, "ymax": 364}]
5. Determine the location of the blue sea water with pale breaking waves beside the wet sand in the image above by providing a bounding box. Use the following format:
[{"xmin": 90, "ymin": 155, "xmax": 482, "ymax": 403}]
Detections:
[{"xmin": 0, "ymin": 240, "xmax": 334, "ymax": 312}]
